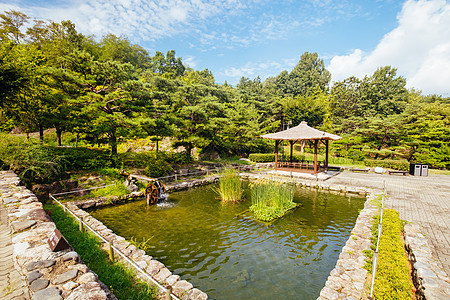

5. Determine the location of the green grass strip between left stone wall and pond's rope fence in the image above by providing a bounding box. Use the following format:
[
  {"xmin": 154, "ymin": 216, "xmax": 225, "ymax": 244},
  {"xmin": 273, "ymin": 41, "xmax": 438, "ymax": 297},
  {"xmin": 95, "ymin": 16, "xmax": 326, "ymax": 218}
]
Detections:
[{"xmin": 45, "ymin": 204, "xmax": 157, "ymax": 300}]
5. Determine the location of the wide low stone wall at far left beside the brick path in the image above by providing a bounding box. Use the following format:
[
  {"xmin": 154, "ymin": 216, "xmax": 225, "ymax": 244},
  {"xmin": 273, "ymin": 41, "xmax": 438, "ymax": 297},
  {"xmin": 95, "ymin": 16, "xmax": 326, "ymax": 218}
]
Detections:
[{"xmin": 0, "ymin": 171, "xmax": 112, "ymax": 300}]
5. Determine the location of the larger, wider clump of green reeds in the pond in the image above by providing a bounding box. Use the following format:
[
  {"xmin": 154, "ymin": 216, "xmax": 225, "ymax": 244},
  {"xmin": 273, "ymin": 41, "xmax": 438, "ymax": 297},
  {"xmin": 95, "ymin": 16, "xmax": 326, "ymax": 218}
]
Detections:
[{"xmin": 250, "ymin": 178, "xmax": 297, "ymax": 222}]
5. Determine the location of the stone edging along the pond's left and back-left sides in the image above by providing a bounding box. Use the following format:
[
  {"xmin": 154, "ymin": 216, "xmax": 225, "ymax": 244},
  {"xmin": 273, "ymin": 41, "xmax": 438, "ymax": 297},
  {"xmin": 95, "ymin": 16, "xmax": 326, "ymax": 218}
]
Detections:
[{"xmin": 62, "ymin": 176, "xmax": 218, "ymax": 300}]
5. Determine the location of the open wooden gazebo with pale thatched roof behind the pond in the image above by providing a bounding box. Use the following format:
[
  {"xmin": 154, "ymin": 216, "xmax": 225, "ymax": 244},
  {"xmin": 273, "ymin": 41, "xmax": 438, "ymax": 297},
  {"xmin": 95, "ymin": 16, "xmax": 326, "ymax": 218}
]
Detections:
[{"xmin": 261, "ymin": 121, "xmax": 341, "ymax": 174}]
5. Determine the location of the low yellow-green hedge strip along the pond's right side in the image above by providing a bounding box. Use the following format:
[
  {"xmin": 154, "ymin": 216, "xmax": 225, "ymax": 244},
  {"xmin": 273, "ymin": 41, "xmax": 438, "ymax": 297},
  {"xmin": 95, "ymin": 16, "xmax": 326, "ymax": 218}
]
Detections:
[{"xmin": 374, "ymin": 209, "xmax": 413, "ymax": 299}]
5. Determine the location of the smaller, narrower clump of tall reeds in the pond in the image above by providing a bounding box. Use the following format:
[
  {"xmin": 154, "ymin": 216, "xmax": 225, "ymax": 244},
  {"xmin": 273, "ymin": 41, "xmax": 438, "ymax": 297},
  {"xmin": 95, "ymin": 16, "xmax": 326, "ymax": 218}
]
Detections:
[{"xmin": 214, "ymin": 168, "xmax": 242, "ymax": 202}]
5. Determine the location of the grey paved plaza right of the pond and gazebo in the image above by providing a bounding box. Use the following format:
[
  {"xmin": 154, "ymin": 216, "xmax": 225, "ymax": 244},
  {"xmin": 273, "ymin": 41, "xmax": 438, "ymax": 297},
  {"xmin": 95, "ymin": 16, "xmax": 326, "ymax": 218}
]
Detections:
[{"xmin": 326, "ymin": 172, "xmax": 450, "ymax": 276}]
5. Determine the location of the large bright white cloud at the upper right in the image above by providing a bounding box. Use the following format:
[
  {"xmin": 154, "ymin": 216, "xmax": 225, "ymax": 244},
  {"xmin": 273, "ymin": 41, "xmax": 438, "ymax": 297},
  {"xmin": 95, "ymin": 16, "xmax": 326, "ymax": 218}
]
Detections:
[{"xmin": 328, "ymin": 0, "xmax": 450, "ymax": 96}]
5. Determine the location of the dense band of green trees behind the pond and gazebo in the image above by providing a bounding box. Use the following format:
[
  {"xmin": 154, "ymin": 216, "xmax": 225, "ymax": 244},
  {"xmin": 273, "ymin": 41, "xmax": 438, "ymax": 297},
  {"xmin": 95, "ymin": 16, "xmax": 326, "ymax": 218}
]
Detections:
[{"xmin": 0, "ymin": 11, "xmax": 450, "ymax": 169}]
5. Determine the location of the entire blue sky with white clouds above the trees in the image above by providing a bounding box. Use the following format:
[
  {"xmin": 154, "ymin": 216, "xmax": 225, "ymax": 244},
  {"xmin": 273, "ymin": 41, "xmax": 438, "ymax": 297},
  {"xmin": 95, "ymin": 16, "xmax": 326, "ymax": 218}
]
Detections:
[{"xmin": 0, "ymin": 0, "xmax": 450, "ymax": 97}]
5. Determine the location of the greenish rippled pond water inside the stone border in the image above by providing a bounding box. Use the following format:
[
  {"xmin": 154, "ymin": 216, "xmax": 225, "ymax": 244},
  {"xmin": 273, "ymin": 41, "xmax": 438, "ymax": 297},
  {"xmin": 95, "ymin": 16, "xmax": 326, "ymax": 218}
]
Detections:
[{"xmin": 91, "ymin": 182, "xmax": 365, "ymax": 299}]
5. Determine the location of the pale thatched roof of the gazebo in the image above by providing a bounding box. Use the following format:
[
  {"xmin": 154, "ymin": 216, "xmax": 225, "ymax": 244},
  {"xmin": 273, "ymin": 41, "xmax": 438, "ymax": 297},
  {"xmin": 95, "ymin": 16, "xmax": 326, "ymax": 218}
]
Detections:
[{"xmin": 261, "ymin": 121, "xmax": 341, "ymax": 141}]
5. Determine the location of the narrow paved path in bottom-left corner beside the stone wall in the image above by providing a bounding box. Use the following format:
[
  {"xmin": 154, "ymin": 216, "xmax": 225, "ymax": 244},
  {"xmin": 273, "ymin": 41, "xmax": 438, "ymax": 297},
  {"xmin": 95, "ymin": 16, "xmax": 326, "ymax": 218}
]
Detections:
[{"xmin": 0, "ymin": 201, "xmax": 30, "ymax": 300}]
